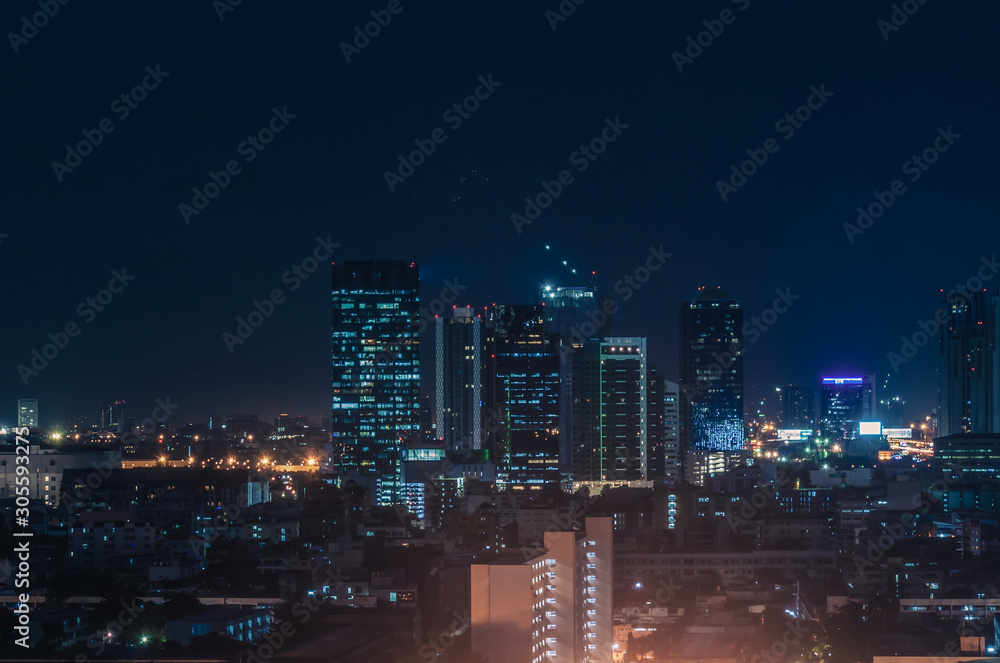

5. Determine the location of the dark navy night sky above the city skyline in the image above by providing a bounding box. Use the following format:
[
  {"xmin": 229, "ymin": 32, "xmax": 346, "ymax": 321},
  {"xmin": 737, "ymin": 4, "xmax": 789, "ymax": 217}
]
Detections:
[{"xmin": 0, "ymin": 0, "xmax": 1000, "ymax": 424}]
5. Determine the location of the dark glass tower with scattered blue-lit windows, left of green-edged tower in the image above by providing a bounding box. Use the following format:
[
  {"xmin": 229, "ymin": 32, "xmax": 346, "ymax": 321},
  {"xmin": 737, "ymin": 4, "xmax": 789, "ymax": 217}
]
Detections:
[{"xmin": 483, "ymin": 305, "xmax": 561, "ymax": 485}]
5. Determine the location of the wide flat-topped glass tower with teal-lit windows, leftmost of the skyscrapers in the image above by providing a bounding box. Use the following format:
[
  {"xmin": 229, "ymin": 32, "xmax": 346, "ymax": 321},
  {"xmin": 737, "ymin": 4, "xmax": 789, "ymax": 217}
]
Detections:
[{"xmin": 330, "ymin": 261, "xmax": 420, "ymax": 505}]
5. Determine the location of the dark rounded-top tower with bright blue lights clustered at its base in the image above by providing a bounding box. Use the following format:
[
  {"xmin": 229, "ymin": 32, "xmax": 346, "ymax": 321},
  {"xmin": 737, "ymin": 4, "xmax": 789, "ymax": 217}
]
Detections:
[{"xmin": 680, "ymin": 288, "xmax": 744, "ymax": 452}]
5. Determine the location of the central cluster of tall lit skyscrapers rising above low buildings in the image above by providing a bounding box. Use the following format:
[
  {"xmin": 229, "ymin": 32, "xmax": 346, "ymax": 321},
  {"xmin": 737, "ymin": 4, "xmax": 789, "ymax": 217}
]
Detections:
[{"xmin": 331, "ymin": 261, "xmax": 744, "ymax": 504}]
